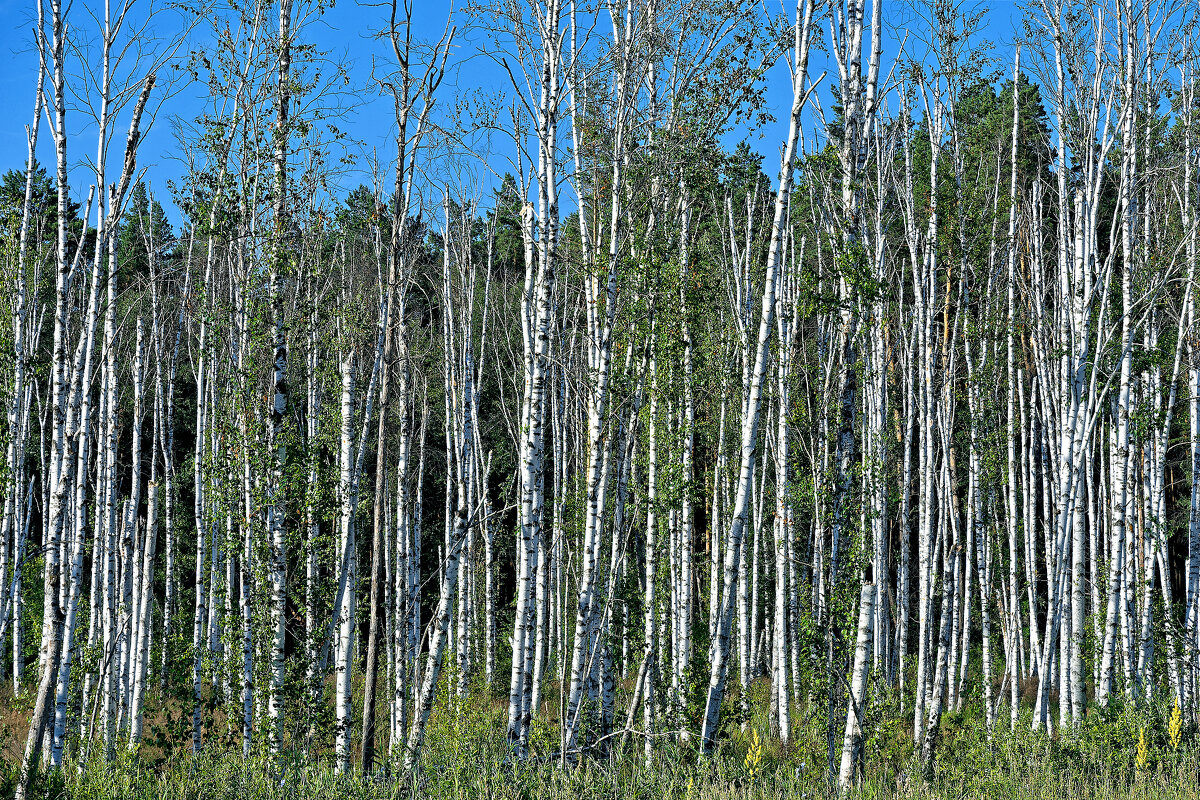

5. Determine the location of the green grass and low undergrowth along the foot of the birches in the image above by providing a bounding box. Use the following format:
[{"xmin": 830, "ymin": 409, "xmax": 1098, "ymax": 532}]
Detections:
[{"xmin": 7, "ymin": 684, "xmax": 1200, "ymax": 800}]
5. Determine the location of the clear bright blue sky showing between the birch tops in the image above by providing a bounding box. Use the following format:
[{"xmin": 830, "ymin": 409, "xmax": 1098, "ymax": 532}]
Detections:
[{"xmin": 0, "ymin": 0, "xmax": 1020, "ymax": 225}]
